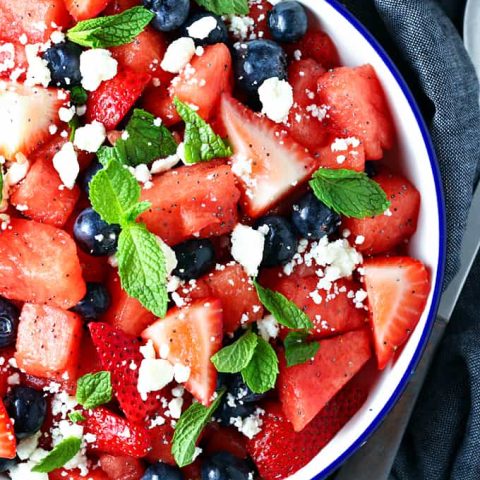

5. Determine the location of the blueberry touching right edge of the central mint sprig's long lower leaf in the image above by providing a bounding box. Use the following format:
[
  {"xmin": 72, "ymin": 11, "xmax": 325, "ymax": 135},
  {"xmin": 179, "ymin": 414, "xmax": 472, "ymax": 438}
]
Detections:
[{"xmin": 173, "ymin": 239, "xmax": 215, "ymax": 280}]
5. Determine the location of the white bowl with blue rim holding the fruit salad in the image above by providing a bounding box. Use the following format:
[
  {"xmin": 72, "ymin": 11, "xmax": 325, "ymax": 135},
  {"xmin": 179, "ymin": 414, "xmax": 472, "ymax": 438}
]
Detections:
[{"xmin": 289, "ymin": 0, "xmax": 446, "ymax": 480}]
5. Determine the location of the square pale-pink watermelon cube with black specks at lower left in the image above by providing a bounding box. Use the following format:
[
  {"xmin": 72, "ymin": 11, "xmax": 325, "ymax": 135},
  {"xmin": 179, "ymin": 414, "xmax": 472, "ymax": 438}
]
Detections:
[{"xmin": 15, "ymin": 303, "xmax": 83, "ymax": 380}]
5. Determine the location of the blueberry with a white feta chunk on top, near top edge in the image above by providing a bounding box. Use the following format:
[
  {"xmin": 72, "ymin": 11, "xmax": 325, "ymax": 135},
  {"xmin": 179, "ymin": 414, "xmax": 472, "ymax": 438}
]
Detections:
[{"xmin": 182, "ymin": 12, "xmax": 228, "ymax": 45}]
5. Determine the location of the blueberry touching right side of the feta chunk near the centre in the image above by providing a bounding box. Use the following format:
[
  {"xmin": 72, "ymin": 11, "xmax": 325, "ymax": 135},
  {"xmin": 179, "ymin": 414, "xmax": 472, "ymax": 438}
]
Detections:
[{"xmin": 254, "ymin": 215, "xmax": 298, "ymax": 267}]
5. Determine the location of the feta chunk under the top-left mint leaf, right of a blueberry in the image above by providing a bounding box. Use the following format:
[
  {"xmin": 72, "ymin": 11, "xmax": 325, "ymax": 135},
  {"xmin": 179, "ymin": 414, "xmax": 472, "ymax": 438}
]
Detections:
[{"xmin": 80, "ymin": 48, "xmax": 118, "ymax": 92}]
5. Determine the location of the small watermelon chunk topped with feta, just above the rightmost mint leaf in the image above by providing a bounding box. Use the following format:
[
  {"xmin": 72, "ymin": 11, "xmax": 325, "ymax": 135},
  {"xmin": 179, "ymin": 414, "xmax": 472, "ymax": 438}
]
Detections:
[{"xmin": 314, "ymin": 135, "xmax": 365, "ymax": 172}]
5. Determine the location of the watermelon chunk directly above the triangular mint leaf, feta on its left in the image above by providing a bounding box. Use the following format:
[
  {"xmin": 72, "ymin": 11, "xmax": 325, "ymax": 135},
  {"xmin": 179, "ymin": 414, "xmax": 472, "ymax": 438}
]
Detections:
[{"xmin": 170, "ymin": 43, "xmax": 233, "ymax": 120}]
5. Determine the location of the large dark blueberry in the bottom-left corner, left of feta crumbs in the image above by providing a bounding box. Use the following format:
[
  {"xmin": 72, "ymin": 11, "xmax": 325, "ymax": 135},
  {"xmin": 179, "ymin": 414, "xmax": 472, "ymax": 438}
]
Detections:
[{"xmin": 5, "ymin": 386, "xmax": 47, "ymax": 439}]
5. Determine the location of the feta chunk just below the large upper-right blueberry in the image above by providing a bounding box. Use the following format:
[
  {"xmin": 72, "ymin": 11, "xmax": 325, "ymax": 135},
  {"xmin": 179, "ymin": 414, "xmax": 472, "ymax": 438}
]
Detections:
[{"xmin": 258, "ymin": 77, "xmax": 293, "ymax": 123}]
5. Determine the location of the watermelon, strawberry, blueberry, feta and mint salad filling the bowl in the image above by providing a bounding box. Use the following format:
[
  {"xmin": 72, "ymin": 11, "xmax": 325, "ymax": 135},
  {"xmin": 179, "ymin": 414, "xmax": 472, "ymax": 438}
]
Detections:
[{"xmin": 0, "ymin": 0, "xmax": 430, "ymax": 480}]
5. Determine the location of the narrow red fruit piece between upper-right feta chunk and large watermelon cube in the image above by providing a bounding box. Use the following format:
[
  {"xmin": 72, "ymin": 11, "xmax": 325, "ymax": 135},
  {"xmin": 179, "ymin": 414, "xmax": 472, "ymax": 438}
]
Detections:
[{"xmin": 287, "ymin": 59, "xmax": 328, "ymax": 153}]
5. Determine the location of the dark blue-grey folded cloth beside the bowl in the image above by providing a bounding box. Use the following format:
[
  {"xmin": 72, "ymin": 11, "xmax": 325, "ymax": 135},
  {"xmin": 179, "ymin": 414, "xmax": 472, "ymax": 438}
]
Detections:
[{"xmin": 336, "ymin": 0, "xmax": 480, "ymax": 480}]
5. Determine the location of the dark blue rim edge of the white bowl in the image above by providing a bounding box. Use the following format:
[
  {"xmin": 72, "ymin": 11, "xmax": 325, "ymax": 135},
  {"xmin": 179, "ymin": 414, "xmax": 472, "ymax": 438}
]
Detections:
[{"xmin": 306, "ymin": 0, "xmax": 447, "ymax": 480}]
